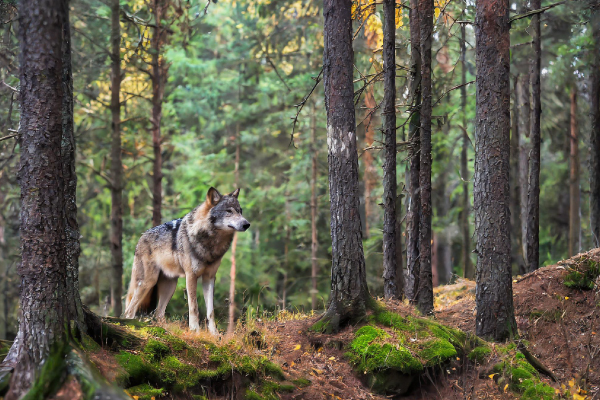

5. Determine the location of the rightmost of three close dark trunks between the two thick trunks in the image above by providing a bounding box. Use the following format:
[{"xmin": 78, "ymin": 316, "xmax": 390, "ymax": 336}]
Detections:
[{"xmin": 416, "ymin": 0, "xmax": 433, "ymax": 314}]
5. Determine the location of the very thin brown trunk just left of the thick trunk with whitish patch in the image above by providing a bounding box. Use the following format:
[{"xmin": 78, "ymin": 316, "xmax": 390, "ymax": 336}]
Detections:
[{"xmin": 310, "ymin": 102, "xmax": 322, "ymax": 310}]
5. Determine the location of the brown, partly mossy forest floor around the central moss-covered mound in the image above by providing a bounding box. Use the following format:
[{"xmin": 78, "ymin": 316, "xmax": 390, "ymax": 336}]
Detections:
[{"xmin": 50, "ymin": 249, "xmax": 600, "ymax": 400}]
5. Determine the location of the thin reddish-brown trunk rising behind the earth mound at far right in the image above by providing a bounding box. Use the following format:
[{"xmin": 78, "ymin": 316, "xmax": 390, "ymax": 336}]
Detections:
[{"xmin": 569, "ymin": 84, "xmax": 580, "ymax": 257}]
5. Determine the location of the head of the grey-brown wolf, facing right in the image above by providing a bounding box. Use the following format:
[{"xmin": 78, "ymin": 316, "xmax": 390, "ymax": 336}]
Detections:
[{"xmin": 206, "ymin": 187, "xmax": 250, "ymax": 232}]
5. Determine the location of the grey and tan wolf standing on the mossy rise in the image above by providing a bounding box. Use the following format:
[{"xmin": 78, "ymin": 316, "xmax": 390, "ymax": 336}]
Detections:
[{"xmin": 124, "ymin": 187, "xmax": 250, "ymax": 335}]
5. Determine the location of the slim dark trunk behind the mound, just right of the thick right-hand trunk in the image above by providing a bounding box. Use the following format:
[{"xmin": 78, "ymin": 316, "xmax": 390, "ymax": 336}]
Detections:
[{"xmin": 527, "ymin": 0, "xmax": 542, "ymax": 271}]
